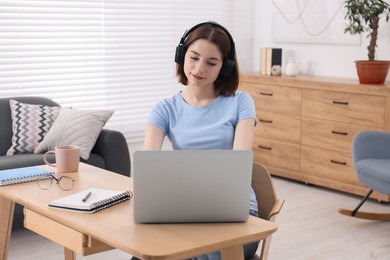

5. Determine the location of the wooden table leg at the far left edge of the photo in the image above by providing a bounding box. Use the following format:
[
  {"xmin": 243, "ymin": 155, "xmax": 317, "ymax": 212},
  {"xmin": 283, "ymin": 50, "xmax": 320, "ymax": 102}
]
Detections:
[{"xmin": 0, "ymin": 197, "xmax": 15, "ymax": 260}]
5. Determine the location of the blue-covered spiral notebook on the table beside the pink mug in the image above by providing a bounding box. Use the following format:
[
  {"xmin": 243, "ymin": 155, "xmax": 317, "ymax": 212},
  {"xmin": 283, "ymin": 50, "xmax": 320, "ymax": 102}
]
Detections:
[{"xmin": 0, "ymin": 166, "xmax": 54, "ymax": 186}]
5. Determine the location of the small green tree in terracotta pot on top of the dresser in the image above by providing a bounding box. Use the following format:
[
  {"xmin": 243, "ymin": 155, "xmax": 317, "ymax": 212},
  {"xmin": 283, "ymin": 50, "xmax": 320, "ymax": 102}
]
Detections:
[{"xmin": 344, "ymin": 0, "xmax": 390, "ymax": 84}]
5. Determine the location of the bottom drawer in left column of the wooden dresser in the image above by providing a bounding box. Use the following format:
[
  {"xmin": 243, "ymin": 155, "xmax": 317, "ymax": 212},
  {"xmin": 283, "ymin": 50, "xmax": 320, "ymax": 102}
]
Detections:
[{"xmin": 253, "ymin": 137, "xmax": 300, "ymax": 171}]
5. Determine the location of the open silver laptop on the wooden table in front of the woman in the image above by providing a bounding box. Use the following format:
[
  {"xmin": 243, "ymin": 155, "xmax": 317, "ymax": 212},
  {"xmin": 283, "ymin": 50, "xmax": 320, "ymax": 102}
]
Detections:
[{"xmin": 132, "ymin": 150, "xmax": 253, "ymax": 223}]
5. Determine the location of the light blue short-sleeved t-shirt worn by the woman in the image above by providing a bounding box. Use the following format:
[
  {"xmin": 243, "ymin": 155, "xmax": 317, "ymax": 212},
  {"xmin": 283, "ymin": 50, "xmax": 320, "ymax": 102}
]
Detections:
[{"xmin": 146, "ymin": 92, "xmax": 258, "ymax": 213}]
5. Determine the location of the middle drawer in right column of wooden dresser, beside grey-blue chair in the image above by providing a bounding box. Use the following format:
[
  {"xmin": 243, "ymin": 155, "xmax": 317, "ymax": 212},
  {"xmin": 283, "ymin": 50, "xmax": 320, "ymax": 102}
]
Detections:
[{"xmin": 302, "ymin": 118, "xmax": 383, "ymax": 153}]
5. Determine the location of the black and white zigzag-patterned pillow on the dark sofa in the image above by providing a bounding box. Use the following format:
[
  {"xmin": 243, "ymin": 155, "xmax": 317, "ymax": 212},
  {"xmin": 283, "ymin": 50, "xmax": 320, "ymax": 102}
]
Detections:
[{"xmin": 7, "ymin": 99, "xmax": 61, "ymax": 155}]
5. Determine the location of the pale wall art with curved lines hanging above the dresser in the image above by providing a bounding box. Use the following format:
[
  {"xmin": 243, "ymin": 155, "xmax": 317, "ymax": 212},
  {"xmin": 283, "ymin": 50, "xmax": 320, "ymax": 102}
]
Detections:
[{"xmin": 272, "ymin": 0, "xmax": 361, "ymax": 45}]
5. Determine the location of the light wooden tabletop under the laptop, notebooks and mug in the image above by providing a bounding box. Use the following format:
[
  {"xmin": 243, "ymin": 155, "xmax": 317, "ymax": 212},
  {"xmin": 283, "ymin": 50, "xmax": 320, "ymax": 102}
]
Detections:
[{"xmin": 0, "ymin": 163, "xmax": 277, "ymax": 259}]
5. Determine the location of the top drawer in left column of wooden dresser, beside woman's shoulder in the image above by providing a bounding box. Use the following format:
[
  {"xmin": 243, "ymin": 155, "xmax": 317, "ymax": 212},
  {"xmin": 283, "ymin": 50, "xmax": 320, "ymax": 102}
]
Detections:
[{"xmin": 240, "ymin": 83, "xmax": 301, "ymax": 115}]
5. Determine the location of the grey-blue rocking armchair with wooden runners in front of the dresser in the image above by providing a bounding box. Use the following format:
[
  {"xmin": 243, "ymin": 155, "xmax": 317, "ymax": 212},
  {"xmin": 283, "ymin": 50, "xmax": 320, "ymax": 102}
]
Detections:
[{"xmin": 339, "ymin": 131, "xmax": 390, "ymax": 221}]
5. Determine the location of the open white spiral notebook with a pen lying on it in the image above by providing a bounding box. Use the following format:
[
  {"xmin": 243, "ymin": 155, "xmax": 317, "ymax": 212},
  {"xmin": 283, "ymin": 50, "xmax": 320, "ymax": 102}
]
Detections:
[{"xmin": 49, "ymin": 188, "xmax": 133, "ymax": 213}]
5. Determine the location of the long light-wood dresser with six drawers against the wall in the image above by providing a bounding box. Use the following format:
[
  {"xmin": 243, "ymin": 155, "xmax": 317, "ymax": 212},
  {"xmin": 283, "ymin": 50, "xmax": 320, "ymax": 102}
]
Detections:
[{"xmin": 240, "ymin": 73, "xmax": 390, "ymax": 202}]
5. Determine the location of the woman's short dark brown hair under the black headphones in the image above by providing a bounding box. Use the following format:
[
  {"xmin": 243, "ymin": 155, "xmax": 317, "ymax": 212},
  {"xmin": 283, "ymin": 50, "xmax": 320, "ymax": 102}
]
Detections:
[{"xmin": 176, "ymin": 22, "xmax": 239, "ymax": 96}]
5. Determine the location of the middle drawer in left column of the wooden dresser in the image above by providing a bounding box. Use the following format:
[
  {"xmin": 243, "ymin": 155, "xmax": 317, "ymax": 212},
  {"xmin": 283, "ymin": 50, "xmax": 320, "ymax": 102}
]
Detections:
[{"xmin": 255, "ymin": 111, "xmax": 301, "ymax": 144}]
